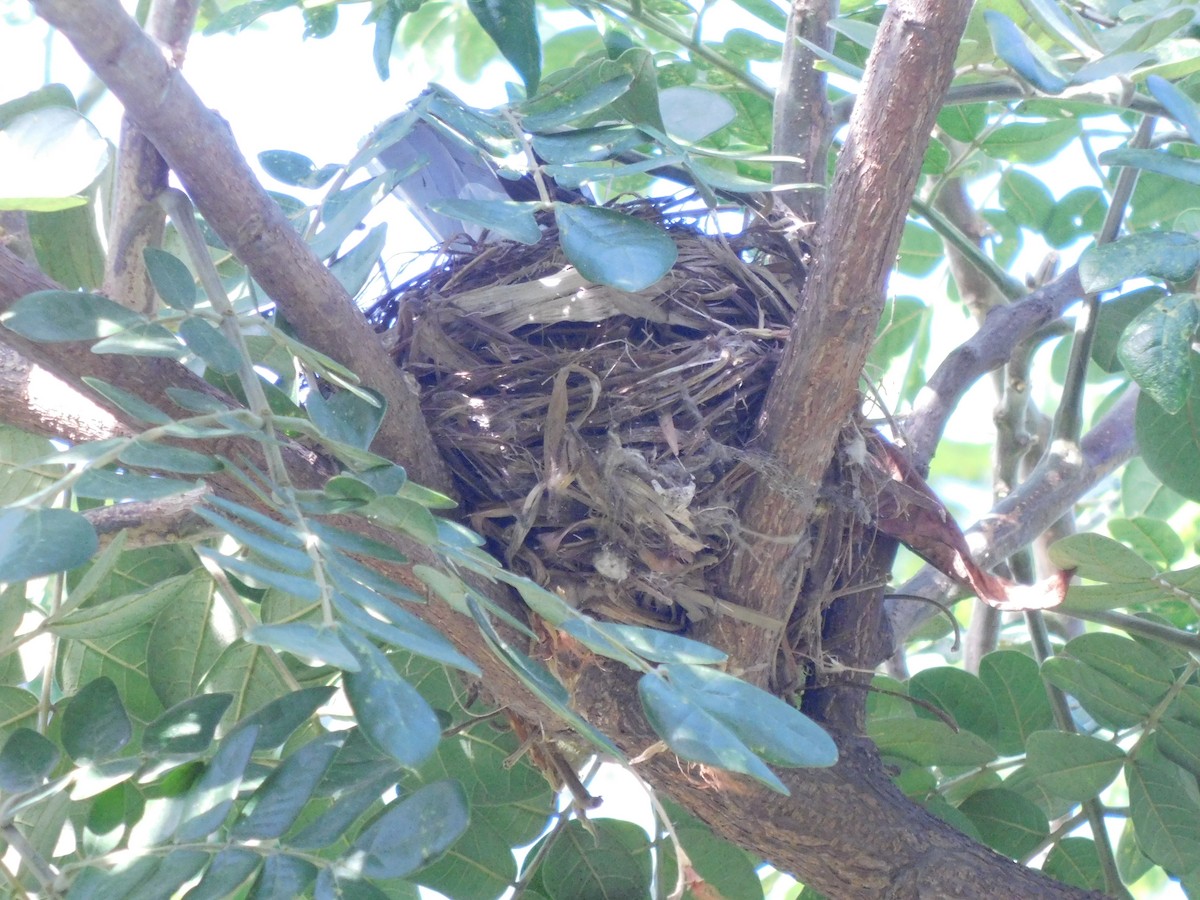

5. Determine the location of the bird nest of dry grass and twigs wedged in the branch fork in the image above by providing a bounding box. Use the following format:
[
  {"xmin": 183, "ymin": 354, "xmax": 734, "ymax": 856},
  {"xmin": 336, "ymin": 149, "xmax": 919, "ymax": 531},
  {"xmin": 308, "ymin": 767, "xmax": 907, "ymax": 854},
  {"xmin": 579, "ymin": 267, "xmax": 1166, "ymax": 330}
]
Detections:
[{"xmin": 368, "ymin": 204, "xmax": 800, "ymax": 629}]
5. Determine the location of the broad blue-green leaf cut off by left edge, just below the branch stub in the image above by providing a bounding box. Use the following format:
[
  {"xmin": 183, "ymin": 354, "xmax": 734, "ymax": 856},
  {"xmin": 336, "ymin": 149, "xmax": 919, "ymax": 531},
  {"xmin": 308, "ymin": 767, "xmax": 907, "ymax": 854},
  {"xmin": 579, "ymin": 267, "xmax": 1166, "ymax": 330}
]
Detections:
[{"xmin": 0, "ymin": 508, "xmax": 98, "ymax": 582}]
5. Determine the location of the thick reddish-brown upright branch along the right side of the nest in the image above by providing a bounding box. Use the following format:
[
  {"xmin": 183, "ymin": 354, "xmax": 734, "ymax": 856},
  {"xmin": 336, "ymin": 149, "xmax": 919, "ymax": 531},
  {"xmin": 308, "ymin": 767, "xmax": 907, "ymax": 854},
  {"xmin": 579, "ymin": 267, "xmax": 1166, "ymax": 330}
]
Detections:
[{"xmin": 716, "ymin": 0, "xmax": 971, "ymax": 683}]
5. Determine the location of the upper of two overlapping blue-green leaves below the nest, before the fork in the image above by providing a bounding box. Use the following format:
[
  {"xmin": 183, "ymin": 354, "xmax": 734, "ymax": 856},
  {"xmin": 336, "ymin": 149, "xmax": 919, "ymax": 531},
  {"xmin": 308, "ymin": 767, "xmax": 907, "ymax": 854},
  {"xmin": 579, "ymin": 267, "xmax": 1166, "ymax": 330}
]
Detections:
[{"xmin": 659, "ymin": 664, "xmax": 838, "ymax": 767}]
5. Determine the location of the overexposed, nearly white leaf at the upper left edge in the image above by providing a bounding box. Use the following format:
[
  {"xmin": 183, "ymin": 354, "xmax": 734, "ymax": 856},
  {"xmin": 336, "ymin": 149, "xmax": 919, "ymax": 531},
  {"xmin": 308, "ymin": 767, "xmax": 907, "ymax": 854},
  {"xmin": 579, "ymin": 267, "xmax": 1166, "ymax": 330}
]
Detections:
[{"xmin": 0, "ymin": 106, "xmax": 110, "ymax": 211}]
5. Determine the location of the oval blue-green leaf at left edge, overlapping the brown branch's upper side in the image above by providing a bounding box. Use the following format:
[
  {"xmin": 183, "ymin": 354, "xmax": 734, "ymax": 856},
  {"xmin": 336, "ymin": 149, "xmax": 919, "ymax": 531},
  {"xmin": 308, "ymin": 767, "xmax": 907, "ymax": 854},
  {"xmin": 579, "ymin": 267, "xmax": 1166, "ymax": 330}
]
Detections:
[{"xmin": 0, "ymin": 290, "xmax": 145, "ymax": 343}]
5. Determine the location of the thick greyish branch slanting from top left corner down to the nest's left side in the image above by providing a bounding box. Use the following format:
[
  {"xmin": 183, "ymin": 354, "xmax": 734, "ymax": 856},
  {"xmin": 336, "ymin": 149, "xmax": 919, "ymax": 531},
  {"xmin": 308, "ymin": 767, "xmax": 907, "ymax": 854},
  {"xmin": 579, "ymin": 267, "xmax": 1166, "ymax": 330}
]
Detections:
[{"xmin": 34, "ymin": 0, "xmax": 450, "ymax": 490}]
